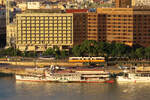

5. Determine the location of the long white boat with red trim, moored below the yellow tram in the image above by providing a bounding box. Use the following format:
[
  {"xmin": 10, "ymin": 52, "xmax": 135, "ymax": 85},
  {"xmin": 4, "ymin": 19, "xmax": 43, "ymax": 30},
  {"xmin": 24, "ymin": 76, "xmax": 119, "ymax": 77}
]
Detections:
[{"xmin": 16, "ymin": 68, "xmax": 114, "ymax": 83}]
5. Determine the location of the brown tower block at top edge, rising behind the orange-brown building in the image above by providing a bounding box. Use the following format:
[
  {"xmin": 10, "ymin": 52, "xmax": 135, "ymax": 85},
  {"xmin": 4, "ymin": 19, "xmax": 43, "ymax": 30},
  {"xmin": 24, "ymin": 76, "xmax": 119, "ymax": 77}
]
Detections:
[{"xmin": 115, "ymin": 0, "xmax": 132, "ymax": 8}]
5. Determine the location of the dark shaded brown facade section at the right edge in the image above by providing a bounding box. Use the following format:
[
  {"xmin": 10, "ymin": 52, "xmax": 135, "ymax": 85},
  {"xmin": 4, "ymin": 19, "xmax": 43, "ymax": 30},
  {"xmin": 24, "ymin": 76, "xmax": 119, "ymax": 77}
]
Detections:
[{"xmin": 133, "ymin": 9, "xmax": 150, "ymax": 47}]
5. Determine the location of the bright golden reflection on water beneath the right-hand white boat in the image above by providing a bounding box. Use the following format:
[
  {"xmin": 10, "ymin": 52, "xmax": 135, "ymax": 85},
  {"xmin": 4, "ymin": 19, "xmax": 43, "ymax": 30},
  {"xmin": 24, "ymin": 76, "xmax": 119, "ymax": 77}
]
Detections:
[{"xmin": 117, "ymin": 83, "xmax": 150, "ymax": 100}]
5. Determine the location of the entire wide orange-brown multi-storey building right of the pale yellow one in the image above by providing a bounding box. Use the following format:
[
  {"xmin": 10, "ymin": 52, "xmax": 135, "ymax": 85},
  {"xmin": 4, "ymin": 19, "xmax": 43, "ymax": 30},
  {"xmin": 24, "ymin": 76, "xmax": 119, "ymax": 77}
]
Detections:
[{"xmin": 70, "ymin": 8, "xmax": 150, "ymax": 47}]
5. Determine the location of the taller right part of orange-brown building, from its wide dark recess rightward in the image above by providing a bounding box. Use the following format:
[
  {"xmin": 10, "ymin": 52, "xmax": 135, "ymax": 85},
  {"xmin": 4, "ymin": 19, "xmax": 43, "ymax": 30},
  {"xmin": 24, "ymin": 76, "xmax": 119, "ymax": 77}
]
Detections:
[{"xmin": 97, "ymin": 8, "xmax": 150, "ymax": 47}]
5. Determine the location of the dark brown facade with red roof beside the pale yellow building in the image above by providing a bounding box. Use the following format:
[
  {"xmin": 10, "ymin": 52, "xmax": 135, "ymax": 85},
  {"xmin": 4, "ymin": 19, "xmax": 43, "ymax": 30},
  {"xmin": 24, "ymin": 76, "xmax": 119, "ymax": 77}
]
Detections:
[{"xmin": 66, "ymin": 9, "xmax": 88, "ymax": 45}]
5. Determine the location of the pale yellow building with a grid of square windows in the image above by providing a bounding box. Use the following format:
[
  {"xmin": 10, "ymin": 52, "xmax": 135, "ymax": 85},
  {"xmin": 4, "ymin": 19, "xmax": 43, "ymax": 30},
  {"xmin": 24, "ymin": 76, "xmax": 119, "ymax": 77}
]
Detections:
[{"xmin": 16, "ymin": 13, "xmax": 73, "ymax": 51}]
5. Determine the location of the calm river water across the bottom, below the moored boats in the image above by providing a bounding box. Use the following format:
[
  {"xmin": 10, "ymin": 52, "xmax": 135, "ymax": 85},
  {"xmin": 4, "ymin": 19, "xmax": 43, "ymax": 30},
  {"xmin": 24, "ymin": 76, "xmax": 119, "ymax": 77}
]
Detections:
[{"xmin": 0, "ymin": 77, "xmax": 150, "ymax": 100}]
